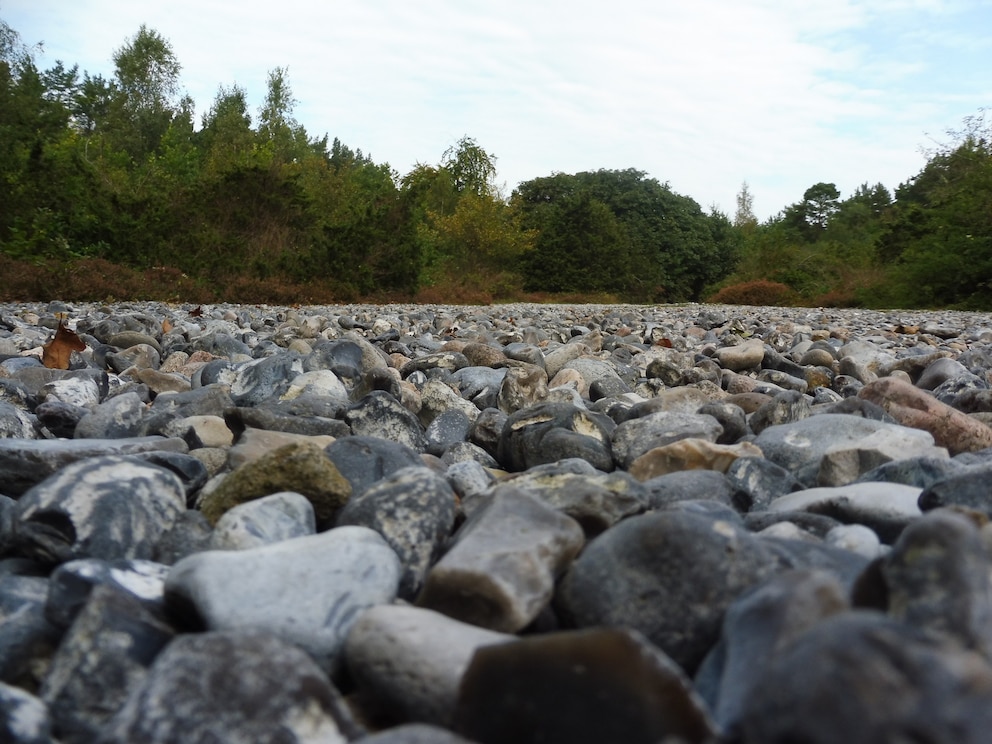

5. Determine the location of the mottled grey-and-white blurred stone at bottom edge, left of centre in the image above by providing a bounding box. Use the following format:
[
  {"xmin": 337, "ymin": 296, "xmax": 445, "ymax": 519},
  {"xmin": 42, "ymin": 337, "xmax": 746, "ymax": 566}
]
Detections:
[{"xmin": 98, "ymin": 630, "xmax": 357, "ymax": 744}]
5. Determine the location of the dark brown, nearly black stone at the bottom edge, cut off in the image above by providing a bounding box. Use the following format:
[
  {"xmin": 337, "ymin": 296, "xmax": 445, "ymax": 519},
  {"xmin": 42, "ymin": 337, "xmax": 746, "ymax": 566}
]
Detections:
[{"xmin": 454, "ymin": 628, "xmax": 717, "ymax": 744}]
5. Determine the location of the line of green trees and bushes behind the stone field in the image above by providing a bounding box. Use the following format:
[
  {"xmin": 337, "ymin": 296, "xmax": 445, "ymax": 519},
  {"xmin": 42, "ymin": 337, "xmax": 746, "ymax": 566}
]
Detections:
[{"xmin": 0, "ymin": 20, "xmax": 992, "ymax": 308}]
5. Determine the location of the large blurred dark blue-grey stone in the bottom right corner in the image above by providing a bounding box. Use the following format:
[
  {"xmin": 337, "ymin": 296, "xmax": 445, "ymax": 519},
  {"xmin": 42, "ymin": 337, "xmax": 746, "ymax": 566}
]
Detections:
[{"xmin": 736, "ymin": 612, "xmax": 992, "ymax": 744}]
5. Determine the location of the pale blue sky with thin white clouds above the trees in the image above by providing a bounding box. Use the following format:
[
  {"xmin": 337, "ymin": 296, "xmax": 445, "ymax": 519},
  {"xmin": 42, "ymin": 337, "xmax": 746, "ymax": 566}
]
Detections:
[{"xmin": 0, "ymin": 0, "xmax": 992, "ymax": 219}]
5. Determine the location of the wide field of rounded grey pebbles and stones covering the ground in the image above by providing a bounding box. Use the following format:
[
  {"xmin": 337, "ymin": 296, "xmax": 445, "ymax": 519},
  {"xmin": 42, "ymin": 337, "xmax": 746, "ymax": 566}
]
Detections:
[{"xmin": 0, "ymin": 302, "xmax": 992, "ymax": 744}]
